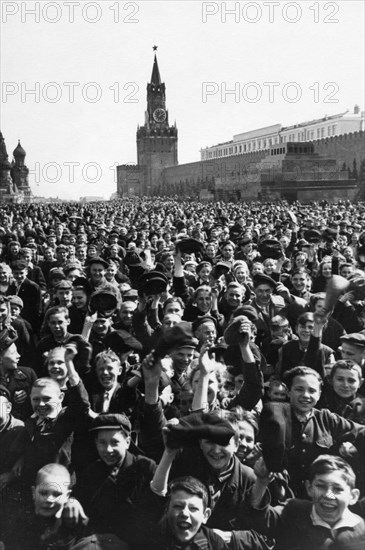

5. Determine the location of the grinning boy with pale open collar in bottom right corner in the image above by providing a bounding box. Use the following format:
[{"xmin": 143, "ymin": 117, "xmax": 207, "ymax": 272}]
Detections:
[{"xmin": 252, "ymin": 455, "xmax": 365, "ymax": 550}]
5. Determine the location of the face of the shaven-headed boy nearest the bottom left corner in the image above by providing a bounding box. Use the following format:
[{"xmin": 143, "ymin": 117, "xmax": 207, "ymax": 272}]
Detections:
[{"xmin": 33, "ymin": 474, "xmax": 71, "ymax": 518}]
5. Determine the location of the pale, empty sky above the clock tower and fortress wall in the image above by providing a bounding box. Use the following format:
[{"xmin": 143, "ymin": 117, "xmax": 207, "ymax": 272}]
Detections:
[{"xmin": 1, "ymin": 0, "xmax": 364, "ymax": 199}]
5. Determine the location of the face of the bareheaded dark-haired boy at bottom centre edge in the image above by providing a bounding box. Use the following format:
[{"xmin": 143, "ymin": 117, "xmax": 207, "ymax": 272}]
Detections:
[{"xmin": 167, "ymin": 490, "xmax": 210, "ymax": 543}]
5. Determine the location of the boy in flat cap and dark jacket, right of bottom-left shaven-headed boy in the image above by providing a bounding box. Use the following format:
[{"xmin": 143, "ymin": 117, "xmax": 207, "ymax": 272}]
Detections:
[{"xmin": 73, "ymin": 414, "xmax": 156, "ymax": 550}]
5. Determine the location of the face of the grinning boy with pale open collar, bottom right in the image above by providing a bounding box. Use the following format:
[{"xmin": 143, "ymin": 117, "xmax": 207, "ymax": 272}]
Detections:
[{"xmin": 307, "ymin": 471, "xmax": 359, "ymax": 525}]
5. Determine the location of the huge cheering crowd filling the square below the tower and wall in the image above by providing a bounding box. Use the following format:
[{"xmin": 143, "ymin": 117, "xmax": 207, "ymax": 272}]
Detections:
[{"xmin": 0, "ymin": 197, "xmax": 365, "ymax": 550}]
